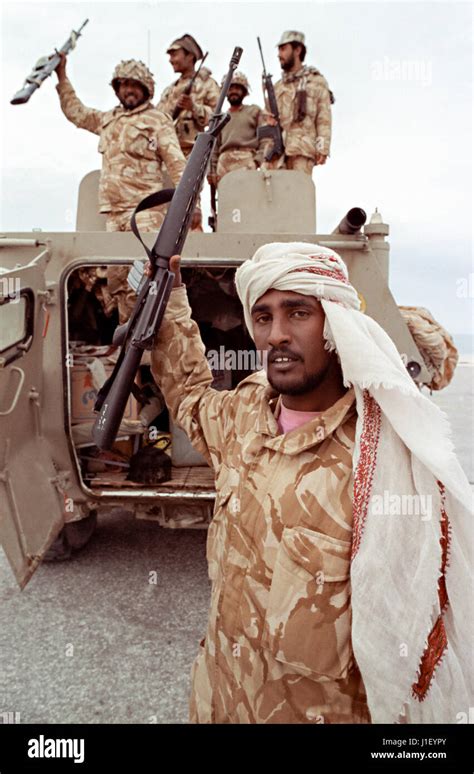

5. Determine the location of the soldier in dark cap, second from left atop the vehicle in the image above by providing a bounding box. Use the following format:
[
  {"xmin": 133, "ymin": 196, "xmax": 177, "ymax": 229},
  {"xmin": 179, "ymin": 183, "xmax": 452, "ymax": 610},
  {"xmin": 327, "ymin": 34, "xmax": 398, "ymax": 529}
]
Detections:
[{"xmin": 157, "ymin": 34, "xmax": 219, "ymax": 231}]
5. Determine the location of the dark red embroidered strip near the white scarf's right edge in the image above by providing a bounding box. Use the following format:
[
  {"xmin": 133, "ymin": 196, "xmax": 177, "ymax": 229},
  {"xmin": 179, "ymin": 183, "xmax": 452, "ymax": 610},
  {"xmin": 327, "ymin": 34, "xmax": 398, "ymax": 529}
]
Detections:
[{"xmin": 412, "ymin": 481, "xmax": 450, "ymax": 701}]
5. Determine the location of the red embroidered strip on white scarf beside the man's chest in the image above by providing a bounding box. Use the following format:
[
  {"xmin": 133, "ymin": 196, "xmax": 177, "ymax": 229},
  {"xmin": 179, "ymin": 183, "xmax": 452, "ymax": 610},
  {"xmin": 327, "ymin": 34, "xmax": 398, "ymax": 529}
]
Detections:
[{"xmin": 351, "ymin": 390, "xmax": 381, "ymax": 559}]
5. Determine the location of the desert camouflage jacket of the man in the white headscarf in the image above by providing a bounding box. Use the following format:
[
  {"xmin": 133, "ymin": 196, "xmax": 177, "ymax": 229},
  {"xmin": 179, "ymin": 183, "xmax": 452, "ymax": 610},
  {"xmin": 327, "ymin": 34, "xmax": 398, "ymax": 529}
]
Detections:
[{"xmin": 152, "ymin": 288, "xmax": 370, "ymax": 723}]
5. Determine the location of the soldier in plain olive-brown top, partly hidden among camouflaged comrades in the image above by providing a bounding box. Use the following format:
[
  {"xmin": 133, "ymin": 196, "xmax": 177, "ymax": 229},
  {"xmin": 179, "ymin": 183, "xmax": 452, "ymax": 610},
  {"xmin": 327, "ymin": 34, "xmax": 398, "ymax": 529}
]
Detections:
[{"xmin": 207, "ymin": 70, "xmax": 265, "ymax": 185}]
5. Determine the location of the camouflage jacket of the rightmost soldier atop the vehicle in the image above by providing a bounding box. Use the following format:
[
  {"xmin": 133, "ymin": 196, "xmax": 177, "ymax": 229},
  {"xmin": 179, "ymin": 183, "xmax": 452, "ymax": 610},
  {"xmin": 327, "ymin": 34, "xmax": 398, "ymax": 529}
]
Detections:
[{"xmin": 275, "ymin": 65, "xmax": 331, "ymax": 159}]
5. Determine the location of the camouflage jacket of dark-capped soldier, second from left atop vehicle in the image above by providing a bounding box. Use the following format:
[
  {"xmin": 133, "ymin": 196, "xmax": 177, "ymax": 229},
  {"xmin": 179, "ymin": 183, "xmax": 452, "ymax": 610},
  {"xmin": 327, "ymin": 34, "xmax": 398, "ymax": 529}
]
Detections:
[{"xmin": 157, "ymin": 75, "xmax": 220, "ymax": 152}]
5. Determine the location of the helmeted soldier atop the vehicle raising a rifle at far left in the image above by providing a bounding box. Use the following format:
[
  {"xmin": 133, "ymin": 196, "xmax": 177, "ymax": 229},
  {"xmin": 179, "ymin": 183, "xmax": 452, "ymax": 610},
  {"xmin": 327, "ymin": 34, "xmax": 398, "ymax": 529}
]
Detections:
[{"xmin": 56, "ymin": 54, "xmax": 186, "ymax": 323}]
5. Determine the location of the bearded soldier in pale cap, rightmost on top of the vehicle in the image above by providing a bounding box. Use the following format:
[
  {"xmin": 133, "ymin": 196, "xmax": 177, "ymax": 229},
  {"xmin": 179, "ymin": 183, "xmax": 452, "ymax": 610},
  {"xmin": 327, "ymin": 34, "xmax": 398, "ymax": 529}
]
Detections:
[{"xmin": 268, "ymin": 30, "xmax": 334, "ymax": 175}]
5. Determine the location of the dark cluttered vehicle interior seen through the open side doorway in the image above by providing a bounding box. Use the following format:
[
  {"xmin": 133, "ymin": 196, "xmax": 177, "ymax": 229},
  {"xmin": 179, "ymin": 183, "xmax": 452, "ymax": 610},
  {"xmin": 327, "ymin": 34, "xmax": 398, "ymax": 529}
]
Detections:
[{"xmin": 67, "ymin": 264, "xmax": 258, "ymax": 500}]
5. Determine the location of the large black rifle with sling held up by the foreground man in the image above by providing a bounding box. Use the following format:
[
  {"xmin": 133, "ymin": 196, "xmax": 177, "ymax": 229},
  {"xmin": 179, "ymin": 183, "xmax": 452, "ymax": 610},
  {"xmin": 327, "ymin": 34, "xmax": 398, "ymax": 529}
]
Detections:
[{"xmin": 92, "ymin": 48, "xmax": 242, "ymax": 449}]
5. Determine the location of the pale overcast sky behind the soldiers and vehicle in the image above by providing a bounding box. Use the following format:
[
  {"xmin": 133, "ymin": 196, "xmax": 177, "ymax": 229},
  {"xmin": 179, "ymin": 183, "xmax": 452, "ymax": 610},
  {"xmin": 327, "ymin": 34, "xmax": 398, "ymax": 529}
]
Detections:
[{"xmin": 0, "ymin": 0, "xmax": 473, "ymax": 342}]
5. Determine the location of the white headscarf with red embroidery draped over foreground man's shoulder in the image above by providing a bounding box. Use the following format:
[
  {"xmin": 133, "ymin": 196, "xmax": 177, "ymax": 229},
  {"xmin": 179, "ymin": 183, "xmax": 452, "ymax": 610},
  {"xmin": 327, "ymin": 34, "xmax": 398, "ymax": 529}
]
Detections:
[{"xmin": 235, "ymin": 242, "xmax": 474, "ymax": 723}]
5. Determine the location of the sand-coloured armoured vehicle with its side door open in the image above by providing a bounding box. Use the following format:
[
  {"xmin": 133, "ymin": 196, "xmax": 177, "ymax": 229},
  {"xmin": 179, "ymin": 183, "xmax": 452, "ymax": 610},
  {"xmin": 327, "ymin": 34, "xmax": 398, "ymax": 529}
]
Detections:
[{"xmin": 0, "ymin": 170, "xmax": 430, "ymax": 587}]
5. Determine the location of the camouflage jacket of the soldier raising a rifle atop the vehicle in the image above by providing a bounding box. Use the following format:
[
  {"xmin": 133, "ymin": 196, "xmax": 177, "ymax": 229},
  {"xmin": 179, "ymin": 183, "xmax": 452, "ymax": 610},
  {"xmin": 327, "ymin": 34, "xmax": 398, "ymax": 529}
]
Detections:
[{"xmin": 56, "ymin": 80, "xmax": 186, "ymax": 212}]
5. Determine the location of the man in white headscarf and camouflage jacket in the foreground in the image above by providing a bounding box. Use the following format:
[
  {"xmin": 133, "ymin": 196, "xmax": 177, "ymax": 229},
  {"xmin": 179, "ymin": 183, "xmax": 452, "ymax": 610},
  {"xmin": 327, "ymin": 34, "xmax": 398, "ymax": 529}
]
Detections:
[{"xmin": 147, "ymin": 242, "xmax": 474, "ymax": 723}]
